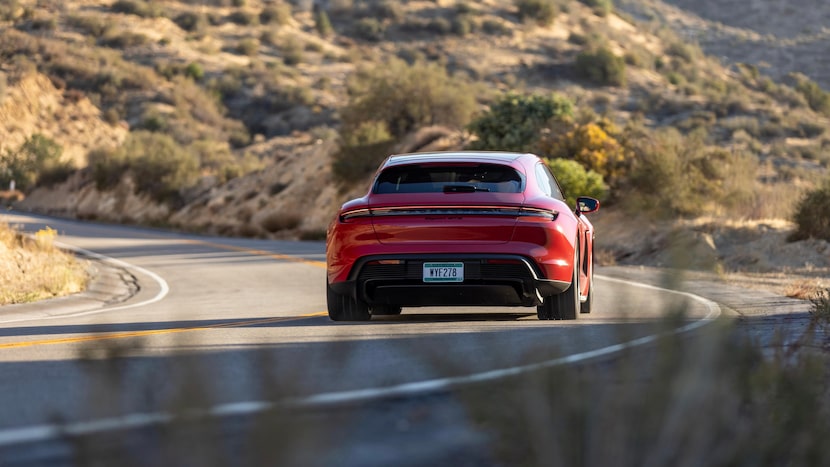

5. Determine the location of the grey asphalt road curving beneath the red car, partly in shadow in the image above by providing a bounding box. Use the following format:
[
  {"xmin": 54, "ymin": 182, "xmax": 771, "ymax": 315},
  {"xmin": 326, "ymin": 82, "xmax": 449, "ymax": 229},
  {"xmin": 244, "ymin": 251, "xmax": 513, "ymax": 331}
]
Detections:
[{"xmin": 0, "ymin": 213, "xmax": 719, "ymax": 465}]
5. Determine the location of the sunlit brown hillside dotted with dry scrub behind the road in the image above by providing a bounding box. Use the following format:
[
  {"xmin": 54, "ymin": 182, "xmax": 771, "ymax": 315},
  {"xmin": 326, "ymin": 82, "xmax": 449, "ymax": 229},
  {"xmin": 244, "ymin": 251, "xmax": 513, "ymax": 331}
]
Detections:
[{"xmin": 0, "ymin": 0, "xmax": 830, "ymax": 282}]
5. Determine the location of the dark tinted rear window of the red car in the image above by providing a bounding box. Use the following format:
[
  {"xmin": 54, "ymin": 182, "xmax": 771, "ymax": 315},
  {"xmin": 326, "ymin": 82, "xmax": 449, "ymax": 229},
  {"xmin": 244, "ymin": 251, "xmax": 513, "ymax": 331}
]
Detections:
[{"xmin": 372, "ymin": 164, "xmax": 523, "ymax": 194}]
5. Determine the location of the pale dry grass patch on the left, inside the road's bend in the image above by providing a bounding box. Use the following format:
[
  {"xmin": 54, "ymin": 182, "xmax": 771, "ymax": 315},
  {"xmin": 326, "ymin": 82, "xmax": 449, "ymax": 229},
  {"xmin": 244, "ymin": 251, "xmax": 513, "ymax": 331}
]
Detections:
[{"xmin": 0, "ymin": 224, "xmax": 88, "ymax": 305}]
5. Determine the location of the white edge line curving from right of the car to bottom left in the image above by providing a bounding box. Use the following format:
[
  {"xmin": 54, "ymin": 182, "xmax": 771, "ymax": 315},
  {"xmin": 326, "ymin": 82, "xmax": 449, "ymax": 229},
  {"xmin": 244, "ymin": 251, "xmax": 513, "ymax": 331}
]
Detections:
[{"xmin": 0, "ymin": 275, "xmax": 721, "ymax": 447}]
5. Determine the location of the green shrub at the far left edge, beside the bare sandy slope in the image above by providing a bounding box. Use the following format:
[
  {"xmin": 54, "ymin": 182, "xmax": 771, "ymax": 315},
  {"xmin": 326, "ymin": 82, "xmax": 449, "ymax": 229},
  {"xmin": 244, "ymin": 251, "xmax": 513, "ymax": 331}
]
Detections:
[{"xmin": 0, "ymin": 133, "xmax": 72, "ymax": 191}]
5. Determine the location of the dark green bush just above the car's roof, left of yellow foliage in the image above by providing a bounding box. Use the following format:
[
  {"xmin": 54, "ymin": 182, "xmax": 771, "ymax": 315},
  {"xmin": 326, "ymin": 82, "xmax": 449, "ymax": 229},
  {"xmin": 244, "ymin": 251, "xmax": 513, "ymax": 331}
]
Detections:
[{"xmin": 468, "ymin": 93, "xmax": 573, "ymax": 152}]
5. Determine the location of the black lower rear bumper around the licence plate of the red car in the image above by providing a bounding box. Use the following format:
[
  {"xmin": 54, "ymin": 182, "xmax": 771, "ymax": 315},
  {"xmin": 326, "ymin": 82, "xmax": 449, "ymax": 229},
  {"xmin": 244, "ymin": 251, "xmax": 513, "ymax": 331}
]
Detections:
[{"xmin": 331, "ymin": 254, "xmax": 571, "ymax": 307}]
